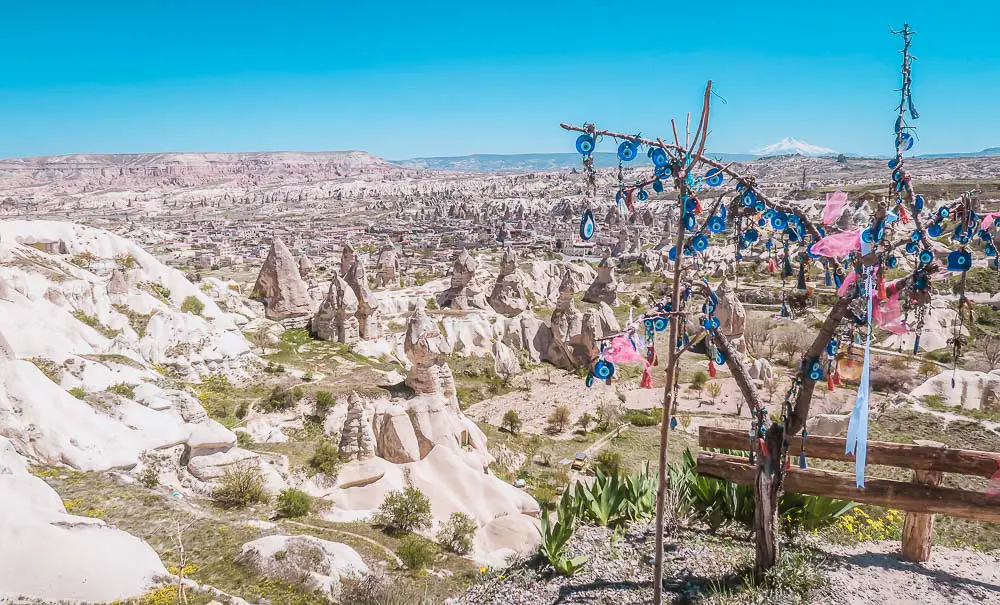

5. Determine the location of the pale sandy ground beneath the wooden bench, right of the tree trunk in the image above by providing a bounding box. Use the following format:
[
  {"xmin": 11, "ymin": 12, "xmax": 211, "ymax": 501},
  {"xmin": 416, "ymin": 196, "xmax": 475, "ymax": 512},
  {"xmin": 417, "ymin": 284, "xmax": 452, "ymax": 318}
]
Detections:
[{"xmin": 816, "ymin": 542, "xmax": 1000, "ymax": 605}]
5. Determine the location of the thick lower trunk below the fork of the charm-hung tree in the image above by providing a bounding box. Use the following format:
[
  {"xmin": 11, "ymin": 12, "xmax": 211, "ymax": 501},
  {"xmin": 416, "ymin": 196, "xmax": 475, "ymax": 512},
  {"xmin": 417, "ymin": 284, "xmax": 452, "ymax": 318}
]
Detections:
[{"xmin": 754, "ymin": 424, "xmax": 785, "ymax": 577}]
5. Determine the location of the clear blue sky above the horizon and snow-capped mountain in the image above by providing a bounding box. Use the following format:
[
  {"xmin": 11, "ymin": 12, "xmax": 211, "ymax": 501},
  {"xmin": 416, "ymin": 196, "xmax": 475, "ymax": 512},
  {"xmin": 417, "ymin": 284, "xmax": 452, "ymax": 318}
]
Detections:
[{"xmin": 0, "ymin": 0, "xmax": 1000, "ymax": 159}]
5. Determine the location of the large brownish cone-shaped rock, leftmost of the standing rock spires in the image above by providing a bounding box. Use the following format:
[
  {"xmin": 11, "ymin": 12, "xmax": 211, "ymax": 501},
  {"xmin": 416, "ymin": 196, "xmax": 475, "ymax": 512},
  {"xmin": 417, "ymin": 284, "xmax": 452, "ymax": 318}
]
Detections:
[{"xmin": 252, "ymin": 237, "xmax": 312, "ymax": 319}]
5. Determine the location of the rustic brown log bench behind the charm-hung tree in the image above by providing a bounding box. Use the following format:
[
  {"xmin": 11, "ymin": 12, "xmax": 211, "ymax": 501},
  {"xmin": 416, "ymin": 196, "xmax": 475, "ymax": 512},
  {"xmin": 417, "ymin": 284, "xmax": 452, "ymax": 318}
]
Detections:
[{"xmin": 698, "ymin": 426, "xmax": 1000, "ymax": 561}]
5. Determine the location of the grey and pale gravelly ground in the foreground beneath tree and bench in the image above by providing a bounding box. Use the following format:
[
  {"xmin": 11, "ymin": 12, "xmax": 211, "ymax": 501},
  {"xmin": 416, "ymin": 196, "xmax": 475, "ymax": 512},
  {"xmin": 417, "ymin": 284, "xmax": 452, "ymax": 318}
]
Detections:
[{"xmin": 448, "ymin": 524, "xmax": 1000, "ymax": 605}]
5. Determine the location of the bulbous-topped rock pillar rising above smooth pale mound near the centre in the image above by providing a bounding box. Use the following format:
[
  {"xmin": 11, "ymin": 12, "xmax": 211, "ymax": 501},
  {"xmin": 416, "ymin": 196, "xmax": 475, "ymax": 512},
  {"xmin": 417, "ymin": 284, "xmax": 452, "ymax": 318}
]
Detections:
[{"xmin": 403, "ymin": 307, "xmax": 458, "ymax": 396}]
